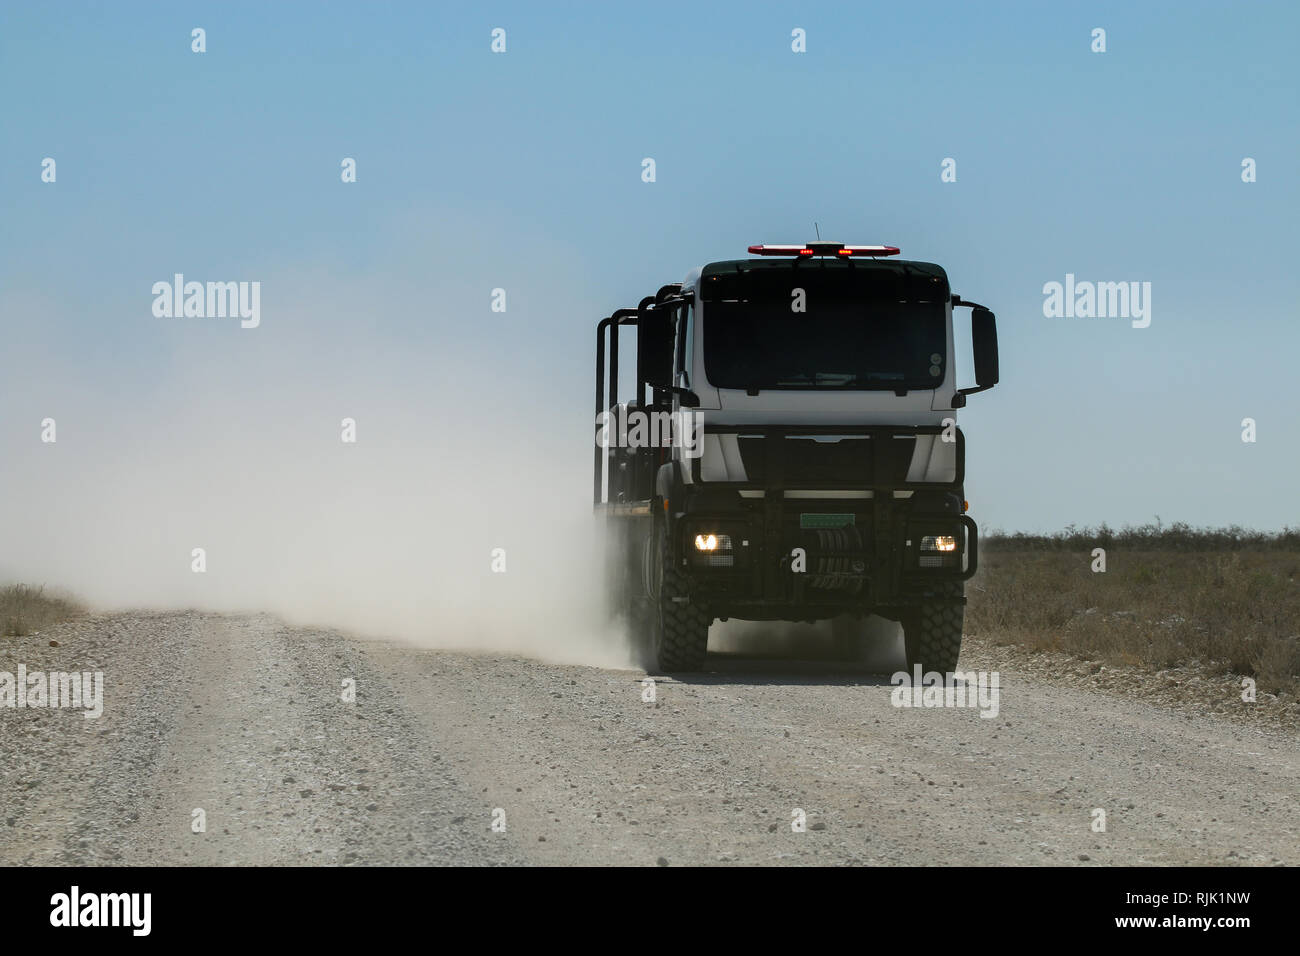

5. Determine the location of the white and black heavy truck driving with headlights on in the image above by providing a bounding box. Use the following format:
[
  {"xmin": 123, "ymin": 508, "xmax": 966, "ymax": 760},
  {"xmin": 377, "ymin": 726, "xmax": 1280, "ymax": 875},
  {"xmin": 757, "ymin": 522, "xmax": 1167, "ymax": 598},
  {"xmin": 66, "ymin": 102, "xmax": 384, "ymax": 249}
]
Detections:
[{"xmin": 594, "ymin": 241, "xmax": 998, "ymax": 674}]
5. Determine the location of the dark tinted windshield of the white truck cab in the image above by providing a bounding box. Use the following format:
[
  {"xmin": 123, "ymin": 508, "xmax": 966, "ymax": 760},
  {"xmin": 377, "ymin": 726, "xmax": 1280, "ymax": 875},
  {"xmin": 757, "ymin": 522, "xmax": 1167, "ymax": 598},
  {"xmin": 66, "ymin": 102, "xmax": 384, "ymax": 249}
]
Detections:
[{"xmin": 701, "ymin": 263, "xmax": 948, "ymax": 390}]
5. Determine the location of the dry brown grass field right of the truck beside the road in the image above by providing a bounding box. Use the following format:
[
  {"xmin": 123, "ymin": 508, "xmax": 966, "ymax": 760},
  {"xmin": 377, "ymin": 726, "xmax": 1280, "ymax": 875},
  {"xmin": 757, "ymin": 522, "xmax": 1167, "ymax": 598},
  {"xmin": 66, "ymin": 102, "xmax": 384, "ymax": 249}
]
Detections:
[{"xmin": 966, "ymin": 548, "xmax": 1300, "ymax": 695}]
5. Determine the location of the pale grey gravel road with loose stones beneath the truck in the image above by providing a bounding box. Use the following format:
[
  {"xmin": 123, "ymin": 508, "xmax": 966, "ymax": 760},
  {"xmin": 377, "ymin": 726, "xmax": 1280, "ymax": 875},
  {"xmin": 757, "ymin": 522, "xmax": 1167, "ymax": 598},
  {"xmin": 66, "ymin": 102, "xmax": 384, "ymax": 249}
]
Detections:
[{"xmin": 0, "ymin": 611, "xmax": 1300, "ymax": 866}]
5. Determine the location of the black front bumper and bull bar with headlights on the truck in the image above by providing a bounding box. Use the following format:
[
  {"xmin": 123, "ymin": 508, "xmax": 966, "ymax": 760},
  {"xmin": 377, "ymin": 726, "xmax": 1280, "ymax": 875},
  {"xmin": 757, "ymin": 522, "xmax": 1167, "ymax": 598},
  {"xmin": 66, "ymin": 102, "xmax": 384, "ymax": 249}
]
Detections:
[{"xmin": 668, "ymin": 425, "xmax": 979, "ymax": 620}]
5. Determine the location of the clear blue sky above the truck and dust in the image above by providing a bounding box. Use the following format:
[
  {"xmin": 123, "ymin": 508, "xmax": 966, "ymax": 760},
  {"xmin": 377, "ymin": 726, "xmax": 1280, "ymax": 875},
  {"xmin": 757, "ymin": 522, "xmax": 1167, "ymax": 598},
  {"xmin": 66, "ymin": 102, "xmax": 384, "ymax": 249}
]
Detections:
[{"xmin": 0, "ymin": 3, "xmax": 1300, "ymax": 538}]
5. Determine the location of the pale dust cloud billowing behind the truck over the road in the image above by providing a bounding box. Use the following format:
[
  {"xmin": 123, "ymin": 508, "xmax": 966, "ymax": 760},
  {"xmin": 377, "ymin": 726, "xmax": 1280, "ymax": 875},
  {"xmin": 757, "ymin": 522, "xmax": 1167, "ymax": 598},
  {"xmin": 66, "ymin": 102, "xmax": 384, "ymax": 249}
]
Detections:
[{"xmin": 0, "ymin": 273, "xmax": 634, "ymax": 666}]
